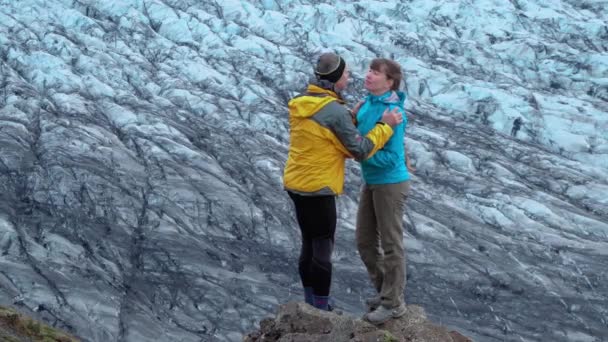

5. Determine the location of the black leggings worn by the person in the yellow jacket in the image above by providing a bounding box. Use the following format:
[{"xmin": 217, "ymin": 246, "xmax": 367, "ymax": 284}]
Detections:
[{"xmin": 289, "ymin": 192, "xmax": 337, "ymax": 296}]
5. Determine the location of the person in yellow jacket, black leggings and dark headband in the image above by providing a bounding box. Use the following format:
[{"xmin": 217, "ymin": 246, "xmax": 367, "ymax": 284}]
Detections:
[{"xmin": 283, "ymin": 53, "xmax": 403, "ymax": 310}]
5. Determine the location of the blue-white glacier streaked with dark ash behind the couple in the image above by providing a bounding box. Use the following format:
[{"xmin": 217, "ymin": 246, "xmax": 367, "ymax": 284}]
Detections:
[{"xmin": 0, "ymin": 0, "xmax": 608, "ymax": 342}]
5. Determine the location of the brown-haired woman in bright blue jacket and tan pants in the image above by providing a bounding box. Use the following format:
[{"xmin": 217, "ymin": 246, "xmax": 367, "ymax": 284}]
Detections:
[{"xmin": 353, "ymin": 58, "xmax": 410, "ymax": 324}]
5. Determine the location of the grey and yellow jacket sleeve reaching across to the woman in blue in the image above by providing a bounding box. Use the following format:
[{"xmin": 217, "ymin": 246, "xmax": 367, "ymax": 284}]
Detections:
[{"xmin": 329, "ymin": 108, "xmax": 393, "ymax": 161}]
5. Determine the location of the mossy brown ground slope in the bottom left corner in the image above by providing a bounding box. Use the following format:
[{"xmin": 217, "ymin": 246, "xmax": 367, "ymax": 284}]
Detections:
[{"xmin": 0, "ymin": 306, "xmax": 79, "ymax": 342}]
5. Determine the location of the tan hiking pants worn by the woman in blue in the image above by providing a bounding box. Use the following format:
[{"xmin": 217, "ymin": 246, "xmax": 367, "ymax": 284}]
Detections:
[{"xmin": 356, "ymin": 181, "xmax": 410, "ymax": 308}]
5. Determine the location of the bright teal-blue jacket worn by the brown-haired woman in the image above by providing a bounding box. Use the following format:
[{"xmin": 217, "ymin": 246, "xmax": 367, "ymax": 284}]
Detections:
[{"xmin": 357, "ymin": 91, "xmax": 410, "ymax": 184}]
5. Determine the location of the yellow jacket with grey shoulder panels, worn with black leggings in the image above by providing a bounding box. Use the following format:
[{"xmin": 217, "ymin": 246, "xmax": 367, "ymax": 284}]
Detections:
[{"xmin": 283, "ymin": 84, "xmax": 393, "ymax": 195}]
